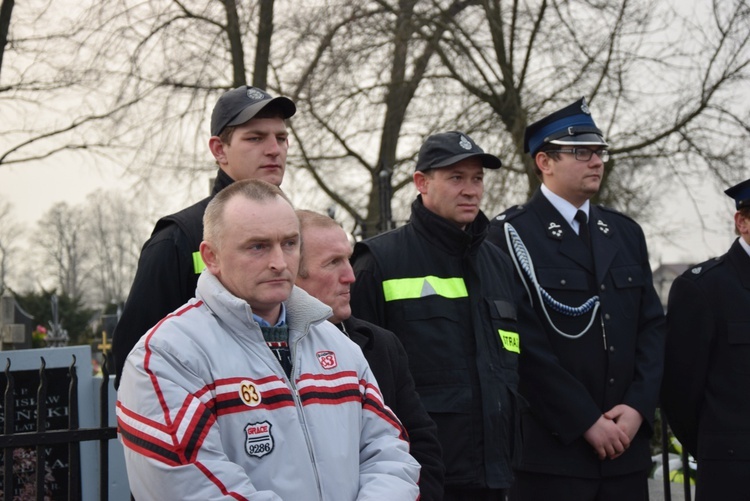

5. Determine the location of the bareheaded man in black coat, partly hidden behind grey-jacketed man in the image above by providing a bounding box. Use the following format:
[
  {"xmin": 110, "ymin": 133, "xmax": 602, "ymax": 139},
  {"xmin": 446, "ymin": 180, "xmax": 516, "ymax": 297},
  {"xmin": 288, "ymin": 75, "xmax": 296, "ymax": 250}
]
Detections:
[{"xmin": 296, "ymin": 210, "xmax": 445, "ymax": 501}]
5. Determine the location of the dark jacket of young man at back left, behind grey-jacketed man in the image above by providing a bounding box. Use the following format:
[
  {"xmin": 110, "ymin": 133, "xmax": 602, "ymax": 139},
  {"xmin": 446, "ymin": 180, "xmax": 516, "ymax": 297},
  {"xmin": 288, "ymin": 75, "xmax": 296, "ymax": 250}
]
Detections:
[{"xmin": 112, "ymin": 169, "xmax": 234, "ymax": 388}]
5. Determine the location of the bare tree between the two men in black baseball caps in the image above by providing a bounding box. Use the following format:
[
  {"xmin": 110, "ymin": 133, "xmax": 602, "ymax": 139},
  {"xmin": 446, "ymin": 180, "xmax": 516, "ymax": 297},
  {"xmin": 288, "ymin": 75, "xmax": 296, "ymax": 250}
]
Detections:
[{"xmin": 282, "ymin": 0, "xmax": 472, "ymax": 237}]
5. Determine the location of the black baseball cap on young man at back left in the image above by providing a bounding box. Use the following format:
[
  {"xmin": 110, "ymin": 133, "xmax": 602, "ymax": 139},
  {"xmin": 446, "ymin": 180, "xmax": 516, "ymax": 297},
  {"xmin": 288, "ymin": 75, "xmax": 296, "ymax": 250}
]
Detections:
[{"xmin": 211, "ymin": 85, "xmax": 297, "ymax": 136}]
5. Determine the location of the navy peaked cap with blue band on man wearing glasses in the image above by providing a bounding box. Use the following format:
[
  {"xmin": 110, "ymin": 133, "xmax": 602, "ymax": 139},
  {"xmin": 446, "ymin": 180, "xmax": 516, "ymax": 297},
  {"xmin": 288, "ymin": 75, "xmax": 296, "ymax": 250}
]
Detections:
[{"xmin": 523, "ymin": 97, "xmax": 609, "ymax": 157}]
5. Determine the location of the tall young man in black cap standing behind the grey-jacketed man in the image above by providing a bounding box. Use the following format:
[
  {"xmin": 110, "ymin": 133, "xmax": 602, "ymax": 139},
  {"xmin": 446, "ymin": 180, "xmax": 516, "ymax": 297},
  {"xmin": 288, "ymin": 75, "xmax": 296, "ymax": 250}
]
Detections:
[{"xmin": 112, "ymin": 85, "xmax": 296, "ymax": 387}]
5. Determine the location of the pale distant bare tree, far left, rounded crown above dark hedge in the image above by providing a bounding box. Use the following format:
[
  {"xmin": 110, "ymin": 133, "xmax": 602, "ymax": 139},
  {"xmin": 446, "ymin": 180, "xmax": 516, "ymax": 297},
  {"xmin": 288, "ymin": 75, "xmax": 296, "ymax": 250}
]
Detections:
[{"xmin": 33, "ymin": 202, "xmax": 91, "ymax": 298}]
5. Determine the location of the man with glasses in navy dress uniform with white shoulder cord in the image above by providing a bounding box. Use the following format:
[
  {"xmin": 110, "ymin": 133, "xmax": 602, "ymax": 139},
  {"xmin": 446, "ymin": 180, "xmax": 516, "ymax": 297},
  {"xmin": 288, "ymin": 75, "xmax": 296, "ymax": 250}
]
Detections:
[{"xmin": 488, "ymin": 99, "xmax": 664, "ymax": 501}]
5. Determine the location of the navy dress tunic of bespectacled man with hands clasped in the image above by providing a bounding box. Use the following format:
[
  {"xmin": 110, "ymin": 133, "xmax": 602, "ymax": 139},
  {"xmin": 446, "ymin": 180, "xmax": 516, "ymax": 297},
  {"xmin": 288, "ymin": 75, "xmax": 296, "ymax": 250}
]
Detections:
[{"xmin": 488, "ymin": 191, "xmax": 664, "ymax": 479}]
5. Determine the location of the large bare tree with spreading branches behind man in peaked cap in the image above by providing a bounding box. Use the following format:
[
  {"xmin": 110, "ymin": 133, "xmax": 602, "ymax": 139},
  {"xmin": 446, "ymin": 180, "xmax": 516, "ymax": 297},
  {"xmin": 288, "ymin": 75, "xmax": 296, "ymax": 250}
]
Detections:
[{"xmin": 424, "ymin": 0, "xmax": 750, "ymax": 219}]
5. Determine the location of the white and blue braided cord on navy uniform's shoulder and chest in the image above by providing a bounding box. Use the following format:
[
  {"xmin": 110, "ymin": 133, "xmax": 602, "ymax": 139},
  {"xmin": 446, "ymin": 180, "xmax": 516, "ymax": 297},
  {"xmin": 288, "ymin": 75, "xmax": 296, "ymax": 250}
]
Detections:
[{"xmin": 504, "ymin": 223, "xmax": 599, "ymax": 339}]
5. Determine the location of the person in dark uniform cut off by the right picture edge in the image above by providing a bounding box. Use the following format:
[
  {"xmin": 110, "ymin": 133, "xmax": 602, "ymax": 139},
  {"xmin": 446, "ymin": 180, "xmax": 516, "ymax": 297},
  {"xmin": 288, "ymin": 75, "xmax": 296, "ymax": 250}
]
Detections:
[{"xmin": 662, "ymin": 179, "xmax": 750, "ymax": 501}]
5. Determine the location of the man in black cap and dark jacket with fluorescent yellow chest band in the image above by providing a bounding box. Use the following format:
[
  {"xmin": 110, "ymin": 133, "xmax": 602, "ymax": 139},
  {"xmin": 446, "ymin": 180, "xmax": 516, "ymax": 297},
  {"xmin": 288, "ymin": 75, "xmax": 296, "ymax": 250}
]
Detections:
[{"xmin": 351, "ymin": 131, "xmax": 532, "ymax": 501}]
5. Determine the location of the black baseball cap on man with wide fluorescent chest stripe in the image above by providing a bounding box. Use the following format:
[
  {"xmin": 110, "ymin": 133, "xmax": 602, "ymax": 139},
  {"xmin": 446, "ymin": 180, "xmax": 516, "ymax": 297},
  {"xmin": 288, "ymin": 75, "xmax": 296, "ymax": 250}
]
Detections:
[{"xmin": 416, "ymin": 130, "xmax": 502, "ymax": 172}]
